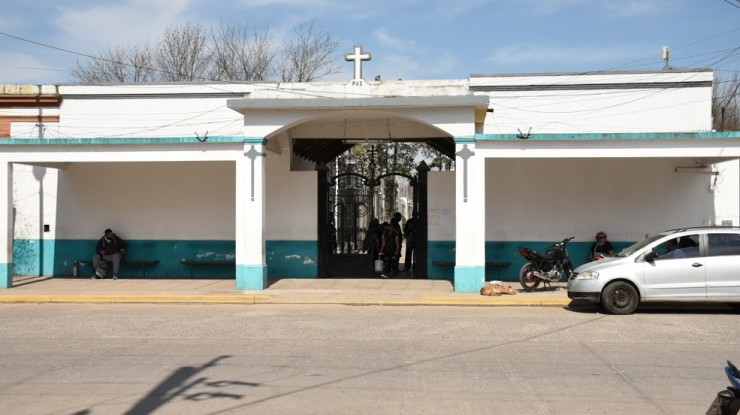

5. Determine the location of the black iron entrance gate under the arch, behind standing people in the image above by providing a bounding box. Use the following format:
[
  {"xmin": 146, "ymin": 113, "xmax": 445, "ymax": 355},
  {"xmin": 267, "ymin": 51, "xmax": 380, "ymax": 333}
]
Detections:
[{"xmin": 318, "ymin": 163, "xmax": 429, "ymax": 278}]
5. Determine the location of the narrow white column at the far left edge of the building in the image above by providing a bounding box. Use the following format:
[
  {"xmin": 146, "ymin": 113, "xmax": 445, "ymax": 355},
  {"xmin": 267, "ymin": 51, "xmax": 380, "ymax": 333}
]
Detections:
[{"xmin": 0, "ymin": 161, "xmax": 13, "ymax": 288}]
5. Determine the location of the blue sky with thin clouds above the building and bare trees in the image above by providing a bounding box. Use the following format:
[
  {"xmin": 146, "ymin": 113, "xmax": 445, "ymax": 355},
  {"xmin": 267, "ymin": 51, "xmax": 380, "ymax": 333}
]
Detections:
[{"xmin": 0, "ymin": 0, "xmax": 740, "ymax": 84}]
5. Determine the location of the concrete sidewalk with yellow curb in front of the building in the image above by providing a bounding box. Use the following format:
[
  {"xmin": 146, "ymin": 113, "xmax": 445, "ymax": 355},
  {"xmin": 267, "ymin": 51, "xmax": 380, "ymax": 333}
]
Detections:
[{"xmin": 0, "ymin": 277, "xmax": 570, "ymax": 307}]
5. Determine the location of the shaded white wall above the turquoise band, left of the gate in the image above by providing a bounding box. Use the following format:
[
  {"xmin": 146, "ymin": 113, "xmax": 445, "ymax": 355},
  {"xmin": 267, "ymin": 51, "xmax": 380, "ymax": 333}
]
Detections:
[{"xmin": 14, "ymin": 152, "xmax": 317, "ymax": 244}]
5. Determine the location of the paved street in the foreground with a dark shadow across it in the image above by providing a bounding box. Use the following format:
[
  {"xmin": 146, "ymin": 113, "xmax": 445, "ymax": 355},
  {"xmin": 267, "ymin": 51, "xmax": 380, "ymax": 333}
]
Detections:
[{"xmin": 0, "ymin": 304, "xmax": 740, "ymax": 415}]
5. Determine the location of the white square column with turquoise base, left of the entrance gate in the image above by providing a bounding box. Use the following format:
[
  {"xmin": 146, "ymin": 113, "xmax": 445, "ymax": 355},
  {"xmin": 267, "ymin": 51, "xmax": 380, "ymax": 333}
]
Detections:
[{"xmin": 236, "ymin": 138, "xmax": 267, "ymax": 290}]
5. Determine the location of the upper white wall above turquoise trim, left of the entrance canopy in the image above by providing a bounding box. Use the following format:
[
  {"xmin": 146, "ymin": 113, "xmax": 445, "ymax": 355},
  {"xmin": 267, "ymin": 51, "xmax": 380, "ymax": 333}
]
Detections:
[{"xmin": 59, "ymin": 84, "xmax": 253, "ymax": 138}]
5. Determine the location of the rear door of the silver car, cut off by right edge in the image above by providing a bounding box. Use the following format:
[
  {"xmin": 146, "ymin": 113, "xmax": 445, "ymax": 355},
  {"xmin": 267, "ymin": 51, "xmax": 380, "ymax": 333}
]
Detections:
[{"xmin": 706, "ymin": 232, "xmax": 740, "ymax": 300}]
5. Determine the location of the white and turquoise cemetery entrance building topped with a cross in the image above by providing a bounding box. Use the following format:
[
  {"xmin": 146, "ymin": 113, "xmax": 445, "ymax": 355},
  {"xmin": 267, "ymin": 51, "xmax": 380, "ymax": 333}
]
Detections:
[{"xmin": 0, "ymin": 48, "xmax": 740, "ymax": 291}]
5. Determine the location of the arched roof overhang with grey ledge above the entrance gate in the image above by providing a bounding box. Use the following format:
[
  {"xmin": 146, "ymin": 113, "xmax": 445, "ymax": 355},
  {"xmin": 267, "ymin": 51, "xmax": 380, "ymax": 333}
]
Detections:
[{"xmin": 227, "ymin": 95, "xmax": 489, "ymax": 163}]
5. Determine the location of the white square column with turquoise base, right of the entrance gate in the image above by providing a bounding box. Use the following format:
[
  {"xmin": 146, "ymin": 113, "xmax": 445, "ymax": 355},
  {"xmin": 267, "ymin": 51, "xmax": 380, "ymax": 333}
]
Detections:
[{"xmin": 455, "ymin": 139, "xmax": 486, "ymax": 292}]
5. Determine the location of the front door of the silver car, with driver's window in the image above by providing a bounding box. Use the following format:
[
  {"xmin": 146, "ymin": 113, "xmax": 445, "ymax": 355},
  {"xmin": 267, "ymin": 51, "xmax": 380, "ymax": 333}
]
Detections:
[{"xmin": 642, "ymin": 234, "xmax": 707, "ymax": 300}]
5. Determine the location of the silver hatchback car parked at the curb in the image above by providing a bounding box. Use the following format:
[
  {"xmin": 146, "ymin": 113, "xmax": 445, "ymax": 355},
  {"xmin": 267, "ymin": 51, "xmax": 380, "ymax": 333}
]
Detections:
[{"xmin": 568, "ymin": 227, "xmax": 740, "ymax": 314}]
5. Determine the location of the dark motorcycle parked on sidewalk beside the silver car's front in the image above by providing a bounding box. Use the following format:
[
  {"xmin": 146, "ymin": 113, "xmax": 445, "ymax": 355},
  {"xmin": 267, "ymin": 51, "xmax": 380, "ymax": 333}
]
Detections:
[{"xmin": 519, "ymin": 236, "xmax": 574, "ymax": 291}]
